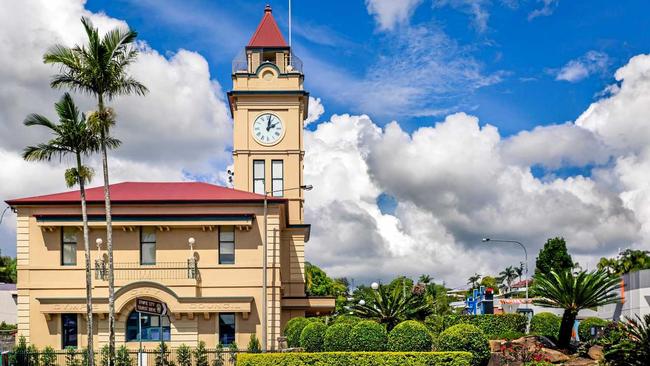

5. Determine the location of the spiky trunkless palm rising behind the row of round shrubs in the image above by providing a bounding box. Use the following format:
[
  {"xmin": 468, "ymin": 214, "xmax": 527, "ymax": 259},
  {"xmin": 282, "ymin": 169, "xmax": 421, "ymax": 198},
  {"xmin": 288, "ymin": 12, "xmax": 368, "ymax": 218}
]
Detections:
[{"xmin": 352, "ymin": 285, "xmax": 428, "ymax": 331}]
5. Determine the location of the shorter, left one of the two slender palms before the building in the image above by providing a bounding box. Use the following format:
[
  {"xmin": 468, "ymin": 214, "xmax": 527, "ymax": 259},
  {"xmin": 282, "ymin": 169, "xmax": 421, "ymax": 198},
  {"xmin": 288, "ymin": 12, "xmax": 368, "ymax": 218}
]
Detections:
[{"xmin": 23, "ymin": 93, "xmax": 119, "ymax": 366}]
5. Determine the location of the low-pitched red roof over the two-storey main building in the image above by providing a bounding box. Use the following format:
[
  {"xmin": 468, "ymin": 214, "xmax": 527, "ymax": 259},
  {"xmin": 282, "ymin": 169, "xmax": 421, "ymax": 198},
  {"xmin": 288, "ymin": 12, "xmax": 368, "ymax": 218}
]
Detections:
[{"xmin": 7, "ymin": 182, "xmax": 282, "ymax": 206}]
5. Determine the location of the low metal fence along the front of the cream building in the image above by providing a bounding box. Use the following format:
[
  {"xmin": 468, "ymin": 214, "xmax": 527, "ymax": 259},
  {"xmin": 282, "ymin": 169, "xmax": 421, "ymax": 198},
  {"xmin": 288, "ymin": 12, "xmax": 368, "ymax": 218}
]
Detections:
[{"xmin": 2, "ymin": 348, "xmax": 253, "ymax": 366}]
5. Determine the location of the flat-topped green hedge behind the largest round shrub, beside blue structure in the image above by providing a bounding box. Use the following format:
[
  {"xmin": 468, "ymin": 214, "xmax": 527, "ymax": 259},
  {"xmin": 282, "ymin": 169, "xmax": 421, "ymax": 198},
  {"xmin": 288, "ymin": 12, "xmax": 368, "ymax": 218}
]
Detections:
[{"xmin": 440, "ymin": 314, "xmax": 526, "ymax": 339}]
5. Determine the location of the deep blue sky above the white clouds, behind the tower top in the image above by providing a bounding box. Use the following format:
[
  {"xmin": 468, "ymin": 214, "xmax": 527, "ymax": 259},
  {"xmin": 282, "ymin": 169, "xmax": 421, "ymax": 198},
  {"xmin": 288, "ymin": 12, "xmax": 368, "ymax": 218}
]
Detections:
[{"xmin": 86, "ymin": 0, "xmax": 650, "ymax": 136}]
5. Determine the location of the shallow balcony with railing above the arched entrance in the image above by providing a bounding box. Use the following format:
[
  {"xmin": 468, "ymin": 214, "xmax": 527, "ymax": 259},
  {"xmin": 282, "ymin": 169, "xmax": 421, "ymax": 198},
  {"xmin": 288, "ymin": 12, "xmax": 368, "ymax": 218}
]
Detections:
[{"xmin": 94, "ymin": 259, "xmax": 199, "ymax": 281}]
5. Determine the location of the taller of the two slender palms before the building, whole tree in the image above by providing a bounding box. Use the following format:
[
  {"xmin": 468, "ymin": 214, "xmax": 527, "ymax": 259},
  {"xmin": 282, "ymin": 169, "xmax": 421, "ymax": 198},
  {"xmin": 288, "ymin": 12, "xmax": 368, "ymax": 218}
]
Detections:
[{"xmin": 43, "ymin": 18, "xmax": 148, "ymax": 366}]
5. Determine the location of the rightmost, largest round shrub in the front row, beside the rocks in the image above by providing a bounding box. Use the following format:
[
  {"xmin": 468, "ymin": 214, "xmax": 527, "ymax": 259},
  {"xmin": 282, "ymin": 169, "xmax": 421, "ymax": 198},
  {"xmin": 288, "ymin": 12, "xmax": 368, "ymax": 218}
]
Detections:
[{"xmin": 438, "ymin": 324, "xmax": 490, "ymax": 366}]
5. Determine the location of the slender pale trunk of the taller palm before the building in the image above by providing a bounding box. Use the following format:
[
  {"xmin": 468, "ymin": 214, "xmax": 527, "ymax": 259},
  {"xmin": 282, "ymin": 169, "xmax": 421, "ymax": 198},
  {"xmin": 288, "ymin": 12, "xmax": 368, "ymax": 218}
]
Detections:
[{"xmin": 97, "ymin": 93, "xmax": 115, "ymax": 366}]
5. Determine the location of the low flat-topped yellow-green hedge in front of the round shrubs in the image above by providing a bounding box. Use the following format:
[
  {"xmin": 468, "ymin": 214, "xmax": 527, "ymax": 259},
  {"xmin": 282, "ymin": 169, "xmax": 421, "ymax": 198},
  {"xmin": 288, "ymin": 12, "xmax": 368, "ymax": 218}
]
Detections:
[{"xmin": 237, "ymin": 352, "xmax": 472, "ymax": 366}]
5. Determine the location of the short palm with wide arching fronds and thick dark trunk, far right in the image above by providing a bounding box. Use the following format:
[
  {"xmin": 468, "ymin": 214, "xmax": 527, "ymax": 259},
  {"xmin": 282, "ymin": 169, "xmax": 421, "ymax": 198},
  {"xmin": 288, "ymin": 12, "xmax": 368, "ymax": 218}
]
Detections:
[{"xmin": 534, "ymin": 270, "xmax": 620, "ymax": 347}]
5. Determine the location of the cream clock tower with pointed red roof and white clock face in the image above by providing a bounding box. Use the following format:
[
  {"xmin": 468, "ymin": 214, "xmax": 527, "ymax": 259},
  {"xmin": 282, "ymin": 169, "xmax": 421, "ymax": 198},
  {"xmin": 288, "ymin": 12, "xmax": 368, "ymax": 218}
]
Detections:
[{"xmin": 228, "ymin": 5, "xmax": 309, "ymax": 224}]
